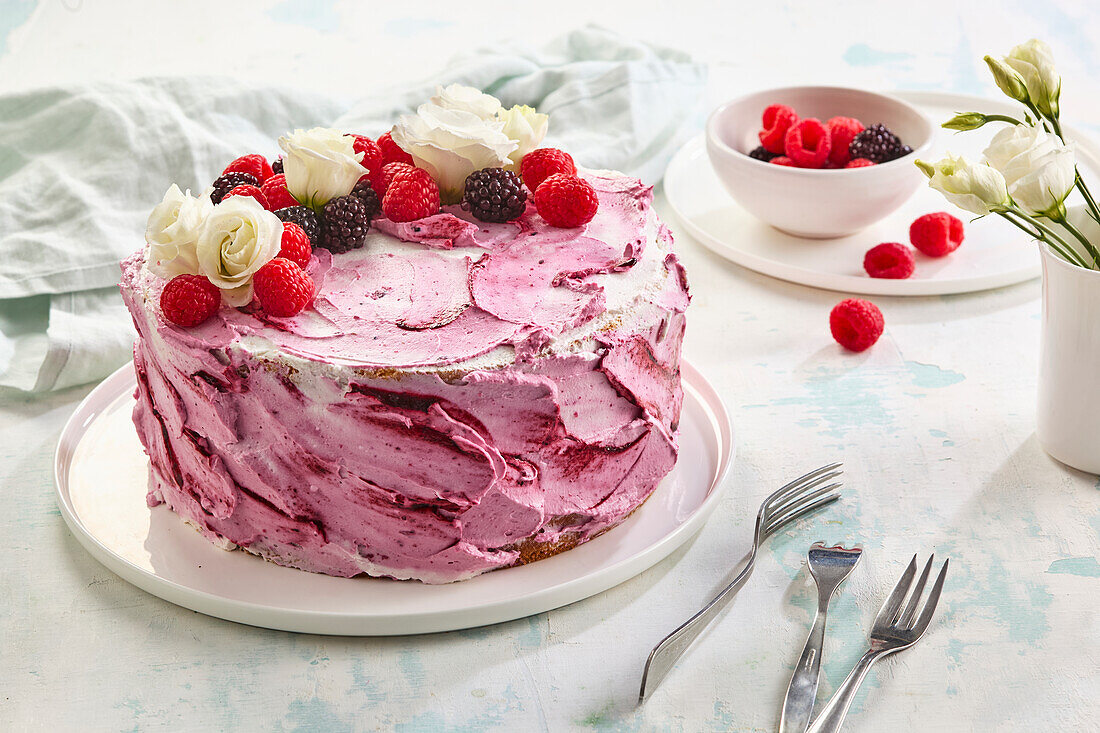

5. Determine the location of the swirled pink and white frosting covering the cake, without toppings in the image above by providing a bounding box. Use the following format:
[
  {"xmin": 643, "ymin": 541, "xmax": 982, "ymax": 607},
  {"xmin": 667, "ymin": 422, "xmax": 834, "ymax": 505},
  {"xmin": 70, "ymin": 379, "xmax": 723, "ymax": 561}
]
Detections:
[{"xmin": 121, "ymin": 157, "xmax": 688, "ymax": 582}]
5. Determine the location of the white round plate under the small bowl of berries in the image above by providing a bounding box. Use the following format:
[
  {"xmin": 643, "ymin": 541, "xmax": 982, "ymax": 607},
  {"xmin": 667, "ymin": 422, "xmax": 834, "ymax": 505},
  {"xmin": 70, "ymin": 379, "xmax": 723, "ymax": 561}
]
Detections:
[{"xmin": 664, "ymin": 91, "xmax": 1100, "ymax": 295}]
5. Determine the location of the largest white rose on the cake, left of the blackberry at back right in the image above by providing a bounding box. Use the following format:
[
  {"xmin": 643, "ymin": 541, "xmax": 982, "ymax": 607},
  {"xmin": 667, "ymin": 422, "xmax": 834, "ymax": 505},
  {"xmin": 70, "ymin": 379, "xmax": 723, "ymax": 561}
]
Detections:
[{"xmin": 392, "ymin": 102, "xmax": 518, "ymax": 204}]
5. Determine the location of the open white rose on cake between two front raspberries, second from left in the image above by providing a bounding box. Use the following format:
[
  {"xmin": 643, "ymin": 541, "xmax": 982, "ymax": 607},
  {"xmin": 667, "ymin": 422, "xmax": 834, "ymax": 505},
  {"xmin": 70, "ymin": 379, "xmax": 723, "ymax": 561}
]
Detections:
[{"xmin": 196, "ymin": 196, "xmax": 283, "ymax": 306}]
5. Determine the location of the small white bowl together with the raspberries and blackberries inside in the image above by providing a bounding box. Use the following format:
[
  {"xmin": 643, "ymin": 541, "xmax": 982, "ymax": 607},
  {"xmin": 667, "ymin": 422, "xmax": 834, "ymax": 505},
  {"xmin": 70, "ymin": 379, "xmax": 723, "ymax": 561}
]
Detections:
[{"xmin": 706, "ymin": 87, "xmax": 934, "ymax": 239}]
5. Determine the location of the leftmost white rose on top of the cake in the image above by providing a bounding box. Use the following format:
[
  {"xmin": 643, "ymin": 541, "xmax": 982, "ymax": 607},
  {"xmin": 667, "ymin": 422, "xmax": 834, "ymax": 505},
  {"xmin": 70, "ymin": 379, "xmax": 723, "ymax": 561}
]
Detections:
[{"xmin": 145, "ymin": 184, "xmax": 213, "ymax": 280}]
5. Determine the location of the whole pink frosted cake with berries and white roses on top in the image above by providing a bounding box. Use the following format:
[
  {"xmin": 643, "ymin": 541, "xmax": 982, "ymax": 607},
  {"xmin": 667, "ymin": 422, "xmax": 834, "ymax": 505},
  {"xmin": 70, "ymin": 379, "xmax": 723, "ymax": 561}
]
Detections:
[{"xmin": 121, "ymin": 87, "xmax": 688, "ymax": 582}]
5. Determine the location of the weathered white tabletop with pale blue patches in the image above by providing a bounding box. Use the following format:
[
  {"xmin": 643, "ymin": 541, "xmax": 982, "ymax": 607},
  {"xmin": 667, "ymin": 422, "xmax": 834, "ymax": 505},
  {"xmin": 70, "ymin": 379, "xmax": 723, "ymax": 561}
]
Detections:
[{"xmin": 0, "ymin": 0, "xmax": 1100, "ymax": 731}]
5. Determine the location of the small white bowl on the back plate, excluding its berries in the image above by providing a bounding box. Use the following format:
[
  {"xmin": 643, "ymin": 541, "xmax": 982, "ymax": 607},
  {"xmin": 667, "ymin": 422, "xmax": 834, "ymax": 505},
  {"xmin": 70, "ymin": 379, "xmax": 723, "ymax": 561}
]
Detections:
[{"xmin": 706, "ymin": 87, "xmax": 933, "ymax": 239}]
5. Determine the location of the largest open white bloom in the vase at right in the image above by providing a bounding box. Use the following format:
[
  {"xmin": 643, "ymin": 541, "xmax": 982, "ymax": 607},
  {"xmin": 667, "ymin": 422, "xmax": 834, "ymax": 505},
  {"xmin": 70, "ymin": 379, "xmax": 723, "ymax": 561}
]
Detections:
[{"xmin": 983, "ymin": 124, "xmax": 1077, "ymax": 216}]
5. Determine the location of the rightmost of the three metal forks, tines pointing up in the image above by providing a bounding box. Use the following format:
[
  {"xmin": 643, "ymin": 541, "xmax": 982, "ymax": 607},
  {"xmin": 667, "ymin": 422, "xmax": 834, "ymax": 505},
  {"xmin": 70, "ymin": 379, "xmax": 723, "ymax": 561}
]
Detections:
[{"xmin": 807, "ymin": 555, "xmax": 950, "ymax": 733}]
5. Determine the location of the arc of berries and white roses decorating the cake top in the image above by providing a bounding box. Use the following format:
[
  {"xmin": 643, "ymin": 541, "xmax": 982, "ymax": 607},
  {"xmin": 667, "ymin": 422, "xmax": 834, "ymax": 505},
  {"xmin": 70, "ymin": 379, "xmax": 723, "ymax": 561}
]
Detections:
[{"xmin": 139, "ymin": 84, "xmax": 600, "ymax": 328}]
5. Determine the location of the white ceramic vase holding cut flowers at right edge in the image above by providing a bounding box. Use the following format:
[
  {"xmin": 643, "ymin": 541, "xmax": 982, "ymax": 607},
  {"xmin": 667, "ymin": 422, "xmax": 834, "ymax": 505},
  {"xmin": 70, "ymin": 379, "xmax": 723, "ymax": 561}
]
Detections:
[{"xmin": 1036, "ymin": 207, "xmax": 1100, "ymax": 474}]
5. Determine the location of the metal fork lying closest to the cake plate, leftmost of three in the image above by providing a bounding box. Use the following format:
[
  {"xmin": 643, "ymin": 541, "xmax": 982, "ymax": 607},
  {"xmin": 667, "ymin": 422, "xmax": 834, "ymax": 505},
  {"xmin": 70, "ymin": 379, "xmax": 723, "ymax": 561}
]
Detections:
[{"xmin": 638, "ymin": 463, "xmax": 842, "ymax": 702}]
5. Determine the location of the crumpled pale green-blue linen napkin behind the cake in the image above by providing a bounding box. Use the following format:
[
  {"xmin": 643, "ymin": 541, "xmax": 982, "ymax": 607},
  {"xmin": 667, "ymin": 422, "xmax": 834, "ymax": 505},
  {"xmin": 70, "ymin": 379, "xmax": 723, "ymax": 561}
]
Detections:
[{"xmin": 0, "ymin": 28, "xmax": 705, "ymax": 392}]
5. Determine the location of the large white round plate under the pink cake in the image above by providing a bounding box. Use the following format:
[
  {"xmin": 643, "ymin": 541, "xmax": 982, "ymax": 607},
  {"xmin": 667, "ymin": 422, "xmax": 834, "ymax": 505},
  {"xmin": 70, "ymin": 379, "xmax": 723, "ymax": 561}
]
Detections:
[{"xmin": 55, "ymin": 363, "xmax": 734, "ymax": 635}]
